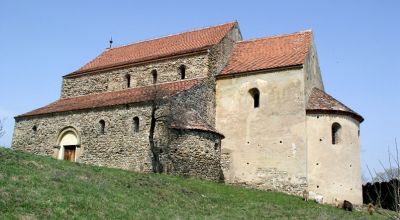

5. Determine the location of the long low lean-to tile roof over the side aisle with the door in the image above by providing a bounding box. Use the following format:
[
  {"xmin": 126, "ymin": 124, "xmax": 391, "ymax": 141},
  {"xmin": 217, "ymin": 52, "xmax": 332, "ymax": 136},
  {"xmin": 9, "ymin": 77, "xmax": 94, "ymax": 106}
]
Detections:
[{"xmin": 15, "ymin": 79, "xmax": 202, "ymax": 118}]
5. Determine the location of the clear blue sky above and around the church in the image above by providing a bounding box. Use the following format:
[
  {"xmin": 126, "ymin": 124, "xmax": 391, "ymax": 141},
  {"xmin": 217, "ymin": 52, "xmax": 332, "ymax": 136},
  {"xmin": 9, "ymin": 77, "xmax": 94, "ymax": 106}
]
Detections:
[{"xmin": 0, "ymin": 0, "xmax": 400, "ymax": 175}]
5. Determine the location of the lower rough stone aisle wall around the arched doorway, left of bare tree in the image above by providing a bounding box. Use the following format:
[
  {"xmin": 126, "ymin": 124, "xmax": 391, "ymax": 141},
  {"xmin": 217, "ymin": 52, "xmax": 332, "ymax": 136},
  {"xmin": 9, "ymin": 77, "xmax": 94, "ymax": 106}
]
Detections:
[{"xmin": 12, "ymin": 104, "xmax": 155, "ymax": 172}]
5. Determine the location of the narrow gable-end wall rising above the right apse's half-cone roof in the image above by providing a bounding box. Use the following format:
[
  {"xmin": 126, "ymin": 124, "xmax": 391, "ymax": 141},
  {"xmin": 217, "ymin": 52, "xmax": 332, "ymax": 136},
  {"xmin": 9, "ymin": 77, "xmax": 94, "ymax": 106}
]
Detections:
[{"xmin": 304, "ymin": 39, "xmax": 324, "ymax": 103}]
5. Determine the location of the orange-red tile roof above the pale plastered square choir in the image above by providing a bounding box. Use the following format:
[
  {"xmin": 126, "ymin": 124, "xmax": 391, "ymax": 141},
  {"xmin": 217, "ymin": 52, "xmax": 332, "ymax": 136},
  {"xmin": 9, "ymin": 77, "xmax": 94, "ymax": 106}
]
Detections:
[{"xmin": 220, "ymin": 31, "xmax": 312, "ymax": 75}]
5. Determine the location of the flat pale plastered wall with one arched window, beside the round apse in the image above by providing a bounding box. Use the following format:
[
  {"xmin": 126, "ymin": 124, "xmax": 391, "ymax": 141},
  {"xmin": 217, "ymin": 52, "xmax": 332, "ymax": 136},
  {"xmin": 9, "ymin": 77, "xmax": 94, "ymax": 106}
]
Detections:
[{"xmin": 216, "ymin": 69, "xmax": 307, "ymax": 194}]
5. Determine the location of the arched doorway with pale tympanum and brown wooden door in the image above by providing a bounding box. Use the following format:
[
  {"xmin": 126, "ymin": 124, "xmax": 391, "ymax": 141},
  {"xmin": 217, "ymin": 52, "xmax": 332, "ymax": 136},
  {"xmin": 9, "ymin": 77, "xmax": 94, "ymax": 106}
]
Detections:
[{"xmin": 57, "ymin": 128, "xmax": 79, "ymax": 161}]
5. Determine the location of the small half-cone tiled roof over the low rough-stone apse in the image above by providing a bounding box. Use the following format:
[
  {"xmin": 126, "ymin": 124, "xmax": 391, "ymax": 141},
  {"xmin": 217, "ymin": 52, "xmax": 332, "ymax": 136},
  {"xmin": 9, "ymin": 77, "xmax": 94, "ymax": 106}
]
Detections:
[{"xmin": 169, "ymin": 110, "xmax": 224, "ymax": 138}]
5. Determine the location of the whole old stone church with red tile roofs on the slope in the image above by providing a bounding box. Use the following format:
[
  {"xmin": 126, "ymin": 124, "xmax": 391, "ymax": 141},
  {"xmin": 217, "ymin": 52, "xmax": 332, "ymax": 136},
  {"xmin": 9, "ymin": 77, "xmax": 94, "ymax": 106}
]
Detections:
[{"xmin": 12, "ymin": 22, "xmax": 363, "ymax": 204}]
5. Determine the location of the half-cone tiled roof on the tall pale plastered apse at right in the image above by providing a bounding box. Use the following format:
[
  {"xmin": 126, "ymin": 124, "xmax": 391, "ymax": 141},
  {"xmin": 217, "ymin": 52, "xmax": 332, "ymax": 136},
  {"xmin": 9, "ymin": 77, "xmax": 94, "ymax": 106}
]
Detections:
[{"xmin": 306, "ymin": 88, "xmax": 364, "ymax": 122}]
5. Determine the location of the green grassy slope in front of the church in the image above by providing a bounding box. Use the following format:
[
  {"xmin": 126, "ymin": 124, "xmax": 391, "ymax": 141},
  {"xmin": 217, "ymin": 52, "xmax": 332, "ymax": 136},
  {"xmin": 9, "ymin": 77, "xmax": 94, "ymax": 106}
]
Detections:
[{"xmin": 0, "ymin": 148, "xmax": 388, "ymax": 219}]
